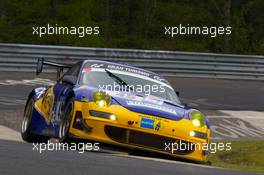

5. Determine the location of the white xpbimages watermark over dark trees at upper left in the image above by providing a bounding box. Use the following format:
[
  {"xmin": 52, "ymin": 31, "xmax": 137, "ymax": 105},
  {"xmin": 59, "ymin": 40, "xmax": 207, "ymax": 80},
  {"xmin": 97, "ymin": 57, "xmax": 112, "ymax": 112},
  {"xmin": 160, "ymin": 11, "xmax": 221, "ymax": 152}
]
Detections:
[{"xmin": 32, "ymin": 24, "xmax": 100, "ymax": 38}]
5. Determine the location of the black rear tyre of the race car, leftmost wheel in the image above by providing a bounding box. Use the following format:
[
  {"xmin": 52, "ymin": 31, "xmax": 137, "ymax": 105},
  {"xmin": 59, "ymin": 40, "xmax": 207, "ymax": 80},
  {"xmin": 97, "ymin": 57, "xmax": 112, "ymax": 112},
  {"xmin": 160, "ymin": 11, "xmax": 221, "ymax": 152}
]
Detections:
[{"xmin": 21, "ymin": 96, "xmax": 49, "ymax": 143}]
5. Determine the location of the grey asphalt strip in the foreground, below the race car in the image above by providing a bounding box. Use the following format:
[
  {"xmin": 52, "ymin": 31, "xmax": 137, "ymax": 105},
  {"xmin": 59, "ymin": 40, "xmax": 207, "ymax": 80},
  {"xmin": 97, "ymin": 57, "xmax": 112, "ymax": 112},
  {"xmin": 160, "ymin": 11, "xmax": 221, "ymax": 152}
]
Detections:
[{"xmin": 0, "ymin": 141, "xmax": 258, "ymax": 175}]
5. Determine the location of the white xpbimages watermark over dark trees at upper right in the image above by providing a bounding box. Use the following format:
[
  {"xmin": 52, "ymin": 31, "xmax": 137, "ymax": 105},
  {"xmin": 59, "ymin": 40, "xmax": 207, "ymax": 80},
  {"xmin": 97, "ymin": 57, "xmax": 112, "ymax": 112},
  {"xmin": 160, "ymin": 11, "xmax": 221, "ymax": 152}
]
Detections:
[{"xmin": 164, "ymin": 24, "xmax": 232, "ymax": 38}]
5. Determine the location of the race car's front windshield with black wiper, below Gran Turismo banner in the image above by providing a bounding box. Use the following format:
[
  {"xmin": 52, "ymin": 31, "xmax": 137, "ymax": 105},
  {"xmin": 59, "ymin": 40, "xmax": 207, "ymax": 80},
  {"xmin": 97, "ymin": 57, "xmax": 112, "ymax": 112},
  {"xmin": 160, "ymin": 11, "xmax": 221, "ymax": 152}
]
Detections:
[{"xmin": 80, "ymin": 68, "xmax": 180, "ymax": 104}]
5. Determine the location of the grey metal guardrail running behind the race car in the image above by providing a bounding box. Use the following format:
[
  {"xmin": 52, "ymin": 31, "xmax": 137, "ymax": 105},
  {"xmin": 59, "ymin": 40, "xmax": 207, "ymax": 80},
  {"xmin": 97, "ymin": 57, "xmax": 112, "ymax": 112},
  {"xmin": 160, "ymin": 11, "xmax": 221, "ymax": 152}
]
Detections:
[{"xmin": 0, "ymin": 44, "xmax": 264, "ymax": 80}]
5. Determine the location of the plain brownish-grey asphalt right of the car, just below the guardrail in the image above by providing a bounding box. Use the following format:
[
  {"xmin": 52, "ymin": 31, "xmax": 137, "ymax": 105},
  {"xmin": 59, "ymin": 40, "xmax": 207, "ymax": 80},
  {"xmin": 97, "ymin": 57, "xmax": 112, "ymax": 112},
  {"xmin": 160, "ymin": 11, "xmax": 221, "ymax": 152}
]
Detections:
[{"xmin": 168, "ymin": 77, "xmax": 264, "ymax": 110}]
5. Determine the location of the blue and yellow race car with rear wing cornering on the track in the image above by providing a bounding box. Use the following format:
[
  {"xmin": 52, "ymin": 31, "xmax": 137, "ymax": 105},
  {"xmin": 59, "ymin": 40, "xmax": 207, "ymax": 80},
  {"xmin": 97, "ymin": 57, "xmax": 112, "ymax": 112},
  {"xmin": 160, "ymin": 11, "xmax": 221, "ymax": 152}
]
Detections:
[{"xmin": 21, "ymin": 58, "xmax": 210, "ymax": 162}]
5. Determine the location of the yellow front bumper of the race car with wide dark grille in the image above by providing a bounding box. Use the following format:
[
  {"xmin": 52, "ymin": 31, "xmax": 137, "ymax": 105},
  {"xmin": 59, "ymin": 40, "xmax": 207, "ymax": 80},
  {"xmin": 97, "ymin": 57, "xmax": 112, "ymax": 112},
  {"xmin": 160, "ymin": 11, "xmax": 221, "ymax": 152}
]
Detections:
[{"xmin": 70, "ymin": 101, "xmax": 210, "ymax": 161}]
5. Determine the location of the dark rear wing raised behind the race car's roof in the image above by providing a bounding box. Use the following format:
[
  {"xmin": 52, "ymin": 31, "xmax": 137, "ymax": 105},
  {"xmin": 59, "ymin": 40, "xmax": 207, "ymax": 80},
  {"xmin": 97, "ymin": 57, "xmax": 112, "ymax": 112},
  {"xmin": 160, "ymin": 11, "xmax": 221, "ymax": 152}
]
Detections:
[{"xmin": 36, "ymin": 58, "xmax": 72, "ymax": 80}]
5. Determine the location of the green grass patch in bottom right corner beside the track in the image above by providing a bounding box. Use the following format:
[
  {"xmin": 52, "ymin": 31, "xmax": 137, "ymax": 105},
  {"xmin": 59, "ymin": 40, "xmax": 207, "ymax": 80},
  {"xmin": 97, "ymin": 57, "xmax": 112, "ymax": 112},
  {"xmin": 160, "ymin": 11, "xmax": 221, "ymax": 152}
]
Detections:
[{"xmin": 208, "ymin": 141, "xmax": 264, "ymax": 173}]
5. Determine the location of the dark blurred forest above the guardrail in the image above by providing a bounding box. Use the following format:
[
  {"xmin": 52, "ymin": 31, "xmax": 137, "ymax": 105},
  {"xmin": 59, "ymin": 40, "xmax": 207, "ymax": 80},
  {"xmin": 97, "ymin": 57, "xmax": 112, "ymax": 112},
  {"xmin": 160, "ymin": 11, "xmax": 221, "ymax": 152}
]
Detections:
[{"xmin": 0, "ymin": 0, "xmax": 264, "ymax": 55}]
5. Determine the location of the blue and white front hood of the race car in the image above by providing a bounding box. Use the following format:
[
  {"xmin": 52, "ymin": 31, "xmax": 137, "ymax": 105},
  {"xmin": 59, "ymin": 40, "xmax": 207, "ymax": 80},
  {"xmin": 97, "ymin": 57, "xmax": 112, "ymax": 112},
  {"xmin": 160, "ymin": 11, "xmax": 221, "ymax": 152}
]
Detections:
[{"xmin": 107, "ymin": 91, "xmax": 185, "ymax": 120}]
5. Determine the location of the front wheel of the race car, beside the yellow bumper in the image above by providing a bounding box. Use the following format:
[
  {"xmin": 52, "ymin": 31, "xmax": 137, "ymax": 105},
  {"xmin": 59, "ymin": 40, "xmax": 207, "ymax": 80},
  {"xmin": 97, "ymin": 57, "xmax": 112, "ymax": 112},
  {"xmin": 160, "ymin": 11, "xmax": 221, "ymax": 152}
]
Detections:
[{"xmin": 59, "ymin": 97, "xmax": 74, "ymax": 143}]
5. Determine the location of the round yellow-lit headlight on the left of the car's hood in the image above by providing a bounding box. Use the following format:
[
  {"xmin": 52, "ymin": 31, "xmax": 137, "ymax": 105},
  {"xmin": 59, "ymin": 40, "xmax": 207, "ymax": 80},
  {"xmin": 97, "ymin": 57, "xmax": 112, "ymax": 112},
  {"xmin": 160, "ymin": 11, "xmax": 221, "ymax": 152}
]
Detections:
[{"xmin": 93, "ymin": 91, "xmax": 112, "ymax": 107}]
